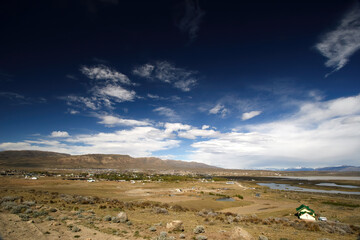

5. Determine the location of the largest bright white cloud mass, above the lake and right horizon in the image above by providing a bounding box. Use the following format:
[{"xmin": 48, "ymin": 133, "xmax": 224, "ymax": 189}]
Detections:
[{"xmin": 190, "ymin": 95, "xmax": 360, "ymax": 168}]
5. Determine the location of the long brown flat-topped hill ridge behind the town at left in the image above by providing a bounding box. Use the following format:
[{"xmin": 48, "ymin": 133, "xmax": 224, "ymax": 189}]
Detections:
[{"xmin": 0, "ymin": 150, "xmax": 219, "ymax": 170}]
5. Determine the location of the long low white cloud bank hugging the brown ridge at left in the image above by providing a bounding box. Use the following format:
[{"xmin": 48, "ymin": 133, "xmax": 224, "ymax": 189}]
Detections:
[{"xmin": 0, "ymin": 126, "xmax": 180, "ymax": 157}]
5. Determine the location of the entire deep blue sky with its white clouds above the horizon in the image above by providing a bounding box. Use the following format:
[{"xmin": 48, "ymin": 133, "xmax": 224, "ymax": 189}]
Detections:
[{"xmin": 0, "ymin": 0, "xmax": 360, "ymax": 169}]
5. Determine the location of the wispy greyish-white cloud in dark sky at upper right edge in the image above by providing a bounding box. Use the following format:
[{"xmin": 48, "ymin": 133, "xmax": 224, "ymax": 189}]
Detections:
[{"xmin": 315, "ymin": 4, "xmax": 360, "ymax": 76}]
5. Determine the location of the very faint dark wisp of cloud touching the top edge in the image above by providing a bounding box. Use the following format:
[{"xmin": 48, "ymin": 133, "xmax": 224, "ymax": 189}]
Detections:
[{"xmin": 176, "ymin": 0, "xmax": 205, "ymax": 41}]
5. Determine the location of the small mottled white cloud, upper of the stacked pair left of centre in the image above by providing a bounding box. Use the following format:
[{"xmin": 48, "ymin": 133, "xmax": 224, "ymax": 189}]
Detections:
[{"xmin": 80, "ymin": 65, "xmax": 132, "ymax": 85}]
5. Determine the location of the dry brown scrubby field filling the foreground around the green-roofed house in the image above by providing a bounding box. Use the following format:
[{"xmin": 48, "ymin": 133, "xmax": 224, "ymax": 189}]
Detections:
[{"xmin": 0, "ymin": 176, "xmax": 360, "ymax": 240}]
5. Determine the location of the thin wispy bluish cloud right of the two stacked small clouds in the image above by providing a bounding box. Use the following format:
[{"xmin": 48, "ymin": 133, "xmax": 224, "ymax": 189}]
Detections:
[{"xmin": 133, "ymin": 61, "xmax": 197, "ymax": 92}]
